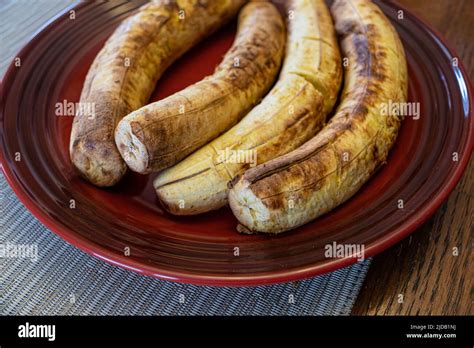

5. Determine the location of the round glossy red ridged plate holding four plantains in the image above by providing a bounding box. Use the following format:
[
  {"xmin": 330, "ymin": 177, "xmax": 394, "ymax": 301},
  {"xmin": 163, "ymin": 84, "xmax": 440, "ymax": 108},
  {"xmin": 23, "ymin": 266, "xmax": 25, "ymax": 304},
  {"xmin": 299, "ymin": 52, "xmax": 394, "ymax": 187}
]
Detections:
[{"xmin": 0, "ymin": 1, "xmax": 473, "ymax": 285}]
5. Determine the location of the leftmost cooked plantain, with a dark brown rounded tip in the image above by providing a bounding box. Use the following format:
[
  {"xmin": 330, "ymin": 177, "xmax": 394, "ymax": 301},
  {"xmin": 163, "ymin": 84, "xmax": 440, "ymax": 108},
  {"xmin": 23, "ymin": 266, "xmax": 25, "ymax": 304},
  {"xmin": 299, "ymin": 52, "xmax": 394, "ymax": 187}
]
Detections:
[{"xmin": 69, "ymin": 0, "xmax": 246, "ymax": 186}]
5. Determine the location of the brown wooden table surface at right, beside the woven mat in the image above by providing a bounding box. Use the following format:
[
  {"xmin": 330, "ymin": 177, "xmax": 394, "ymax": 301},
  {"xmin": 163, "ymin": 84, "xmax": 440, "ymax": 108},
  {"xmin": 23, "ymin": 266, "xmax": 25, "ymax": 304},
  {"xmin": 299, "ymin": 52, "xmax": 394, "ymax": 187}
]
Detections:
[{"xmin": 352, "ymin": 0, "xmax": 474, "ymax": 315}]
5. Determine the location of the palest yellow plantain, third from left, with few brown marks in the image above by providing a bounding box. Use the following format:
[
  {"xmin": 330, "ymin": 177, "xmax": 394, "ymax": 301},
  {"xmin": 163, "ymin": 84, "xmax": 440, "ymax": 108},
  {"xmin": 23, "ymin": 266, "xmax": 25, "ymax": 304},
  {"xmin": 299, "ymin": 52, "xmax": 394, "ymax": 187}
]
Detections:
[{"xmin": 154, "ymin": 0, "xmax": 342, "ymax": 215}]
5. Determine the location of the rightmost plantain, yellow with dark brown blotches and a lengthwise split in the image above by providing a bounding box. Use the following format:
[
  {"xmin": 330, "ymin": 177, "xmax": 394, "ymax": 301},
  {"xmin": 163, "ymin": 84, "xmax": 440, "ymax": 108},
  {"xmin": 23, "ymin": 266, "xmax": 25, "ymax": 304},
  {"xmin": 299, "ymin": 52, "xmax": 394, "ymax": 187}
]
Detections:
[{"xmin": 229, "ymin": 0, "xmax": 407, "ymax": 233}]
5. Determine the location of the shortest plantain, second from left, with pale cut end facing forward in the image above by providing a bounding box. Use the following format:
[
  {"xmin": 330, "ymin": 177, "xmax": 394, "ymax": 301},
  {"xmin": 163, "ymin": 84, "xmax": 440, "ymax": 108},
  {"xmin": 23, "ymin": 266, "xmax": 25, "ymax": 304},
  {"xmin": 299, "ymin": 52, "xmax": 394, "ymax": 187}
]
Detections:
[{"xmin": 115, "ymin": 2, "xmax": 285, "ymax": 174}]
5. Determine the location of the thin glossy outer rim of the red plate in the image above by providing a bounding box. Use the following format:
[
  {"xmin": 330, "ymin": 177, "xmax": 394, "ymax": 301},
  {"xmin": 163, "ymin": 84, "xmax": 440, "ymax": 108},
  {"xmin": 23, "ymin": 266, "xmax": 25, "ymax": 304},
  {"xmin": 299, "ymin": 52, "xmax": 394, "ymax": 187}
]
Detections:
[{"xmin": 0, "ymin": 1, "xmax": 474, "ymax": 286}]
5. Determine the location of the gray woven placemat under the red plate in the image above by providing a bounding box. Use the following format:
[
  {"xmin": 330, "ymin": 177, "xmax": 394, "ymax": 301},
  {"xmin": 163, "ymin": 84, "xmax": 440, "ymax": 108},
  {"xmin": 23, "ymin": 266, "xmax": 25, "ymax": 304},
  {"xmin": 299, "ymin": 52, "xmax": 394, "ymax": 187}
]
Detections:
[{"xmin": 0, "ymin": 0, "xmax": 370, "ymax": 315}]
